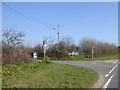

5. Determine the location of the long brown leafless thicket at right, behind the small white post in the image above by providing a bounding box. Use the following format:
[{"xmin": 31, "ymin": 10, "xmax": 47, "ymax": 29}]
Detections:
[{"xmin": 79, "ymin": 38, "xmax": 118, "ymax": 56}]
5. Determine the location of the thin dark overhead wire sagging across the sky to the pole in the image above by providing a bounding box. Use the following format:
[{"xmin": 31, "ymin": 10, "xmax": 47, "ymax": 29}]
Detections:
[{"xmin": 2, "ymin": 3, "xmax": 55, "ymax": 27}]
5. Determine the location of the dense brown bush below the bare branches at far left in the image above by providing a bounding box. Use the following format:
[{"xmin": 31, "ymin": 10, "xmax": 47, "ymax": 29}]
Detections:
[{"xmin": 2, "ymin": 47, "xmax": 32, "ymax": 64}]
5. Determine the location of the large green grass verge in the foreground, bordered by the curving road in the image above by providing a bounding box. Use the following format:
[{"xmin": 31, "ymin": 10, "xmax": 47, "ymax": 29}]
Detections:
[{"xmin": 2, "ymin": 62, "xmax": 98, "ymax": 88}]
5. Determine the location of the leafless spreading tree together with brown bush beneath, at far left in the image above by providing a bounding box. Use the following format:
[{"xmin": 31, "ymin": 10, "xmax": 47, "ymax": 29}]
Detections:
[{"xmin": 2, "ymin": 29, "xmax": 31, "ymax": 64}]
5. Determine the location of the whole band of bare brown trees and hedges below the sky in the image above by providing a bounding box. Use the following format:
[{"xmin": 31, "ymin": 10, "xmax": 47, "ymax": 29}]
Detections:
[{"xmin": 2, "ymin": 29, "xmax": 118, "ymax": 64}]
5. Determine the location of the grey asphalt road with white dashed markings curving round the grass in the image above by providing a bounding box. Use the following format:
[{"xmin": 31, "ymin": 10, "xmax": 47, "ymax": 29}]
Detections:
[{"xmin": 55, "ymin": 60, "xmax": 120, "ymax": 90}]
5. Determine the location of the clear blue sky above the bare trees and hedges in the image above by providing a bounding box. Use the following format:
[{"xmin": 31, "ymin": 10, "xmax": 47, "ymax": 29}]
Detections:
[{"xmin": 2, "ymin": 2, "xmax": 118, "ymax": 46}]
